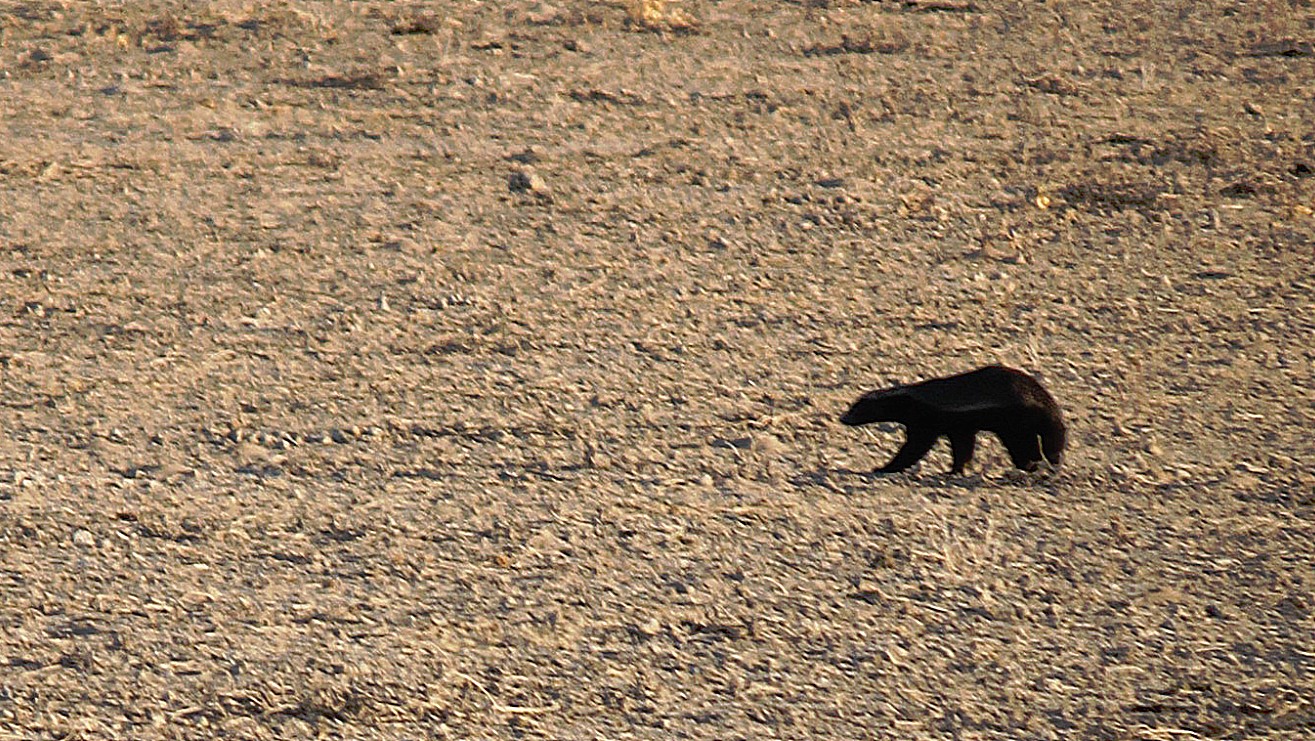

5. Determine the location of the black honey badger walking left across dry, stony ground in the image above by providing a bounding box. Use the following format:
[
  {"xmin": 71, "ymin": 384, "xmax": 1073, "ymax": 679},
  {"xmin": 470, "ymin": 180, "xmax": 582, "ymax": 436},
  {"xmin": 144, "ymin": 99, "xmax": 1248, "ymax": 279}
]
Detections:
[{"xmin": 840, "ymin": 366, "xmax": 1065, "ymax": 474}]
